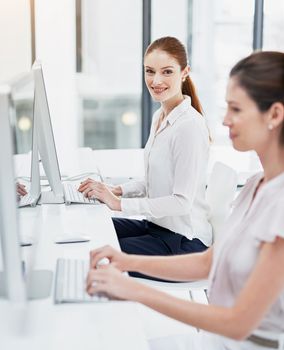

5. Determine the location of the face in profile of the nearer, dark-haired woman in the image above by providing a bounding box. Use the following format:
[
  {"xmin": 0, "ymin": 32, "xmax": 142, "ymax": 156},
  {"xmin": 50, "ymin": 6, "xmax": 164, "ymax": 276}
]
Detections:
[{"xmin": 223, "ymin": 77, "xmax": 271, "ymax": 153}]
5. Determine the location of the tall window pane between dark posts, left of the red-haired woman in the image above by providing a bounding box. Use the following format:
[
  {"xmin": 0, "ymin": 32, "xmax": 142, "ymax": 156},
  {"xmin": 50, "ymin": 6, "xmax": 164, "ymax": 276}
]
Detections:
[{"xmin": 78, "ymin": 0, "xmax": 142, "ymax": 149}]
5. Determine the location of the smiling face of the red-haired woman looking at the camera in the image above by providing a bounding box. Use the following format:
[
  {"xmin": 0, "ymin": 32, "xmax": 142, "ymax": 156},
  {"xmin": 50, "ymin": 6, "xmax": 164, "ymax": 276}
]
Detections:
[{"xmin": 144, "ymin": 50, "xmax": 188, "ymax": 103}]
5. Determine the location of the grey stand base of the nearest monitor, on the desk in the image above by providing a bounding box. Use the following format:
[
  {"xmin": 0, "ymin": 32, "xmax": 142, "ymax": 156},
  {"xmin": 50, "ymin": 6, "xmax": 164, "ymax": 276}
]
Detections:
[{"xmin": 0, "ymin": 270, "xmax": 53, "ymax": 300}]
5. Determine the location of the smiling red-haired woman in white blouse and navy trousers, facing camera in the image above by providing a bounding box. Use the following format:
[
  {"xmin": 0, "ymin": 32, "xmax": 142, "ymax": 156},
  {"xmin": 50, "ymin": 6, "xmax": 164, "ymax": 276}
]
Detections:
[{"xmin": 79, "ymin": 37, "xmax": 212, "ymax": 268}]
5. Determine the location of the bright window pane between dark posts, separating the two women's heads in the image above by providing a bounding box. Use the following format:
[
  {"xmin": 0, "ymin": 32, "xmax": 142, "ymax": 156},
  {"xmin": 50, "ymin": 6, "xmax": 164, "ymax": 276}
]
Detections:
[{"xmin": 192, "ymin": 0, "xmax": 254, "ymax": 144}]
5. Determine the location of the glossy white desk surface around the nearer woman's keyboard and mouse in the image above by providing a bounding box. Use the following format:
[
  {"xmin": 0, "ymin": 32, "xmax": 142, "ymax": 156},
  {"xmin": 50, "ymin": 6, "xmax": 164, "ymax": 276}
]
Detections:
[{"xmin": 0, "ymin": 205, "xmax": 148, "ymax": 350}]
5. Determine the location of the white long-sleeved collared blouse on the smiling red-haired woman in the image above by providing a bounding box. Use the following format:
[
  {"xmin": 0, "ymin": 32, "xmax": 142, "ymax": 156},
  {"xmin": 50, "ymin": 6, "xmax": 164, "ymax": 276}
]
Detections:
[{"xmin": 121, "ymin": 96, "xmax": 212, "ymax": 246}]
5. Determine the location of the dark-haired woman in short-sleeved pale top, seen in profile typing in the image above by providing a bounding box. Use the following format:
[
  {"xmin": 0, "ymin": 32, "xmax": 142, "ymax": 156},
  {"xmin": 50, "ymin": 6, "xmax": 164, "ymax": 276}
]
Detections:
[{"xmin": 87, "ymin": 52, "xmax": 284, "ymax": 350}]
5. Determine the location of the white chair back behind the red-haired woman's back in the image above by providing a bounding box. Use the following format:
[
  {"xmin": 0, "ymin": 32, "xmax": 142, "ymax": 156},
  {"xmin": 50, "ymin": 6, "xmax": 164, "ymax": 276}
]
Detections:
[{"xmin": 206, "ymin": 162, "xmax": 238, "ymax": 241}]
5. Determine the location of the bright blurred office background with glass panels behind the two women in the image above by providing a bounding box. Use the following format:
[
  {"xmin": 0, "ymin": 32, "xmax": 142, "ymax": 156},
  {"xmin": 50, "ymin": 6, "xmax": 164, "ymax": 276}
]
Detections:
[{"xmin": 0, "ymin": 0, "xmax": 284, "ymax": 164}]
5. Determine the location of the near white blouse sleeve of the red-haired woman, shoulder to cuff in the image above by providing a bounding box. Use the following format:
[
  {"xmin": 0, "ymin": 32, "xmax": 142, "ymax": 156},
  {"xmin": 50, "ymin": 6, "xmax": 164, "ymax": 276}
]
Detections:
[{"xmin": 121, "ymin": 117, "xmax": 209, "ymax": 218}]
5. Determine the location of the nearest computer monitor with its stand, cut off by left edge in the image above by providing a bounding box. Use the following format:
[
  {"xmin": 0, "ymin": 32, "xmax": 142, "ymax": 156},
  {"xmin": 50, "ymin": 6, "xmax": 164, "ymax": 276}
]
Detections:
[{"xmin": 0, "ymin": 86, "xmax": 52, "ymax": 303}]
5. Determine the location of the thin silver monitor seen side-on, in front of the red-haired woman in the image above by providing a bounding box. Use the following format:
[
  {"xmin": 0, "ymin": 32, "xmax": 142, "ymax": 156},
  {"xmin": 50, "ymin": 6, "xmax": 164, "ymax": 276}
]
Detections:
[{"xmin": 31, "ymin": 61, "xmax": 64, "ymax": 203}]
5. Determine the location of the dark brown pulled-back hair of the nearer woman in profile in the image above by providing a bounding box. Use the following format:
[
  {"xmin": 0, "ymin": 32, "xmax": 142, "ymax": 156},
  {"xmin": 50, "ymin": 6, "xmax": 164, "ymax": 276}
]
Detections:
[{"xmin": 230, "ymin": 51, "xmax": 284, "ymax": 145}]
